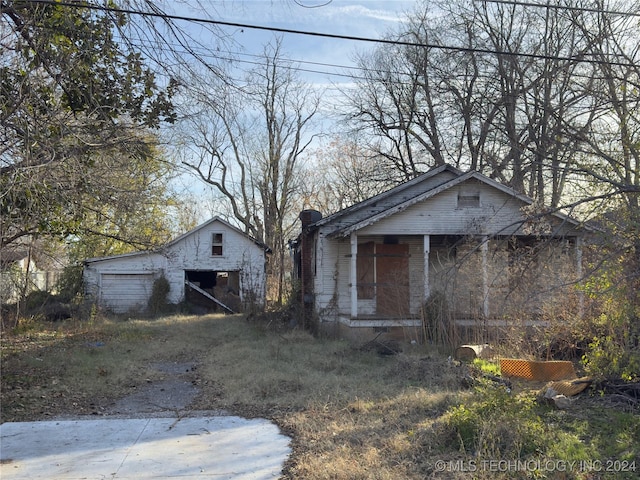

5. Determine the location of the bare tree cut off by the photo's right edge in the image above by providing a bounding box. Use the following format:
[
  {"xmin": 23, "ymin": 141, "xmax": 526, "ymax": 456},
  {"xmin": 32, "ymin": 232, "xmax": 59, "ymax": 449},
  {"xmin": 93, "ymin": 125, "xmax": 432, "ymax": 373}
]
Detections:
[{"xmin": 572, "ymin": 2, "xmax": 640, "ymax": 300}]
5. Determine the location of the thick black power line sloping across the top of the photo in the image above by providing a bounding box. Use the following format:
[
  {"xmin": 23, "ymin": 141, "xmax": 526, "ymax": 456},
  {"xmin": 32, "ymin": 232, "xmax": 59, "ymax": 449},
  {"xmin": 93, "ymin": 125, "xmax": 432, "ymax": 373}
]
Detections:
[{"xmin": 15, "ymin": 0, "xmax": 636, "ymax": 67}]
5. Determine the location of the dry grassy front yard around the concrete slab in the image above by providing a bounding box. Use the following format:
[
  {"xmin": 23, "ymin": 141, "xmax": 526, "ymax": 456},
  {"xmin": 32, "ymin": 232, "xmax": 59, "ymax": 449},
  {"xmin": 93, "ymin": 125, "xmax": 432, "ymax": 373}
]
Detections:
[{"xmin": 1, "ymin": 316, "xmax": 640, "ymax": 479}]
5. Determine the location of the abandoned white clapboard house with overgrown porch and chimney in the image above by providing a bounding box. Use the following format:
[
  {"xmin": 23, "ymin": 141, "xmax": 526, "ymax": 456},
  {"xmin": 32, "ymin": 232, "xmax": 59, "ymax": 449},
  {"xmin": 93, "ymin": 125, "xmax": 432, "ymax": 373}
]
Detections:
[{"xmin": 292, "ymin": 165, "xmax": 583, "ymax": 340}]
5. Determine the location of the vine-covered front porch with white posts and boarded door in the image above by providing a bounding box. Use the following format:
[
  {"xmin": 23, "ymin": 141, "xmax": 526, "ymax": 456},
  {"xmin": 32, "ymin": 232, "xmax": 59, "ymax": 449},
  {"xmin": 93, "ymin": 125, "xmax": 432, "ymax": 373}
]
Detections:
[{"xmin": 342, "ymin": 232, "xmax": 582, "ymax": 322}]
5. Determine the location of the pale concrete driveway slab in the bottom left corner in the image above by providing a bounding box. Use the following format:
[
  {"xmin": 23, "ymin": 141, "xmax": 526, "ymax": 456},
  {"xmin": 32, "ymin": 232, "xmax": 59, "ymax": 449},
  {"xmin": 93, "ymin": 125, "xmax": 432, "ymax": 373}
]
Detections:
[{"xmin": 0, "ymin": 416, "xmax": 291, "ymax": 480}]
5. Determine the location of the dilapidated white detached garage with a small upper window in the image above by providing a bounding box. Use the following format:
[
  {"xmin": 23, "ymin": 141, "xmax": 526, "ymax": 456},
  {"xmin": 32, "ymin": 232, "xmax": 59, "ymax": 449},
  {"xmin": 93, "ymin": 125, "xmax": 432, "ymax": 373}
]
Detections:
[{"xmin": 84, "ymin": 217, "xmax": 271, "ymax": 313}]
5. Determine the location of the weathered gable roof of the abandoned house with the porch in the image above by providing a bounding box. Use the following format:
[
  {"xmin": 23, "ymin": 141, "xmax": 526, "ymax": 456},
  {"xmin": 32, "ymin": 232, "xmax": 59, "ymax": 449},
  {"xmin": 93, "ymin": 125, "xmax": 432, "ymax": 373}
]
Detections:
[{"xmin": 309, "ymin": 165, "xmax": 582, "ymax": 237}]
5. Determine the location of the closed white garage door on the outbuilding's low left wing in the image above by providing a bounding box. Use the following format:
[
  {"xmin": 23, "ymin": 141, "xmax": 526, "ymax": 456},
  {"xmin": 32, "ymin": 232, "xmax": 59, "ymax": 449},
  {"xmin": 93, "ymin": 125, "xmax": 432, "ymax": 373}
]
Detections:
[{"xmin": 100, "ymin": 273, "xmax": 153, "ymax": 313}]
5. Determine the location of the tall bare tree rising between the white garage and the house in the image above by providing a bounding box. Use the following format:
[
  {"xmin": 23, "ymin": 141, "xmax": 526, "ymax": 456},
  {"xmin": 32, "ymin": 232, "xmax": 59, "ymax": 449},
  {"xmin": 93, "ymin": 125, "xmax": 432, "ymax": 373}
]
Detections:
[{"xmin": 183, "ymin": 40, "xmax": 319, "ymax": 302}]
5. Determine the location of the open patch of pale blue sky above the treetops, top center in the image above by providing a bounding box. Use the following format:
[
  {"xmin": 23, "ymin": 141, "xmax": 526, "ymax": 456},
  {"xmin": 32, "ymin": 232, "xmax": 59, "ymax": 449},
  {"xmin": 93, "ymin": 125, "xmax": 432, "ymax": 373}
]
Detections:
[{"xmin": 165, "ymin": 0, "xmax": 418, "ymax": 88}]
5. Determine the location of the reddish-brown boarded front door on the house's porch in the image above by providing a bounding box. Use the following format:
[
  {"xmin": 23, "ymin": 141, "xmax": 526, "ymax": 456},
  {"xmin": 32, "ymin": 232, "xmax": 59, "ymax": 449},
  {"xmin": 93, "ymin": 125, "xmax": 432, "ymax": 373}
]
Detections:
[{"xmin": 375, "ymin": 244, "xmax": 409, "ymax": 318}]
